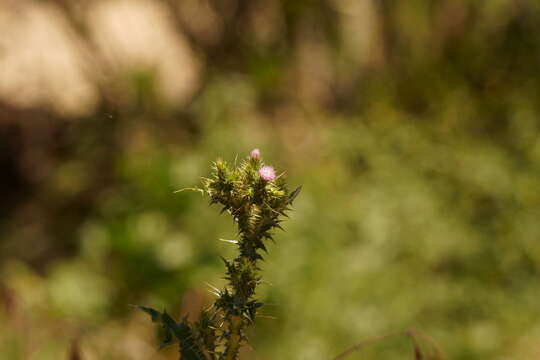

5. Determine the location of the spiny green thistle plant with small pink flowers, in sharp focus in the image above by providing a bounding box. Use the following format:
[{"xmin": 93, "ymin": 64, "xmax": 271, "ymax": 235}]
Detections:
[{"xmin": 139, "ymin": 149, "xmax": 301, "ymax": 360}]
